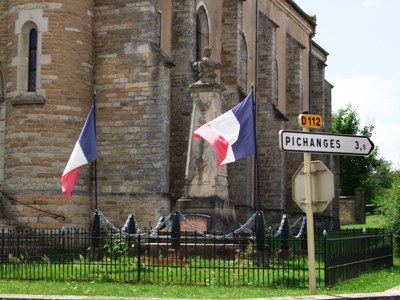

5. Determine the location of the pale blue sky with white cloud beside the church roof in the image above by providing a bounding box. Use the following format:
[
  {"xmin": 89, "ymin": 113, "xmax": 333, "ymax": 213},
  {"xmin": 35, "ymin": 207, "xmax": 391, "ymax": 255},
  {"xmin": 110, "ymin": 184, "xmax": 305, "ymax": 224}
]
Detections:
[{"xmin": 294, "ymin": 0, "xmax": 400, "ymax": 169}]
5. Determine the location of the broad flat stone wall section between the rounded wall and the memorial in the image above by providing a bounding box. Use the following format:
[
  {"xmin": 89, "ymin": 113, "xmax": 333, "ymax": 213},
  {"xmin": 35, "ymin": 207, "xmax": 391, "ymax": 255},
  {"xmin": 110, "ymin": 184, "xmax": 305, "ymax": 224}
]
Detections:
[{"xmin": 94, "ymin": 1, "xmax": 172, "ymax": 224}]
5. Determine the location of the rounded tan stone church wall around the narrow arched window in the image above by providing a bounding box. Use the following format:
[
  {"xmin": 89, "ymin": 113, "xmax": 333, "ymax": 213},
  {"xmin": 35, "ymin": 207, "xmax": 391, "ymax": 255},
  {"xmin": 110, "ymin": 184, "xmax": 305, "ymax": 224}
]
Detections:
[{"xmin": 1, "ymin": 0, "xmax": 93, "ymax": 227}]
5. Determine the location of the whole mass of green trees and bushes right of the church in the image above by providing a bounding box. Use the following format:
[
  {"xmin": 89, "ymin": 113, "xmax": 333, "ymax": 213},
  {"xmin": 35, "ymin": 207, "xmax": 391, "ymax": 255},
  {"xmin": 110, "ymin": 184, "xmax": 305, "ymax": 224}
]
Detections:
[{"xmin": 332, "ymin": 105, "xmax": 400, "ymax": 244}]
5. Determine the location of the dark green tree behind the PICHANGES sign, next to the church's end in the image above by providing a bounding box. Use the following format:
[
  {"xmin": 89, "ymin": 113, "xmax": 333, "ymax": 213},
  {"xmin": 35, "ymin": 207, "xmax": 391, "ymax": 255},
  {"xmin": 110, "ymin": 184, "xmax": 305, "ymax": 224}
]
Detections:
[{"xmin": 332, "ymin": 105, "xmax": 380, "ymax": 198}]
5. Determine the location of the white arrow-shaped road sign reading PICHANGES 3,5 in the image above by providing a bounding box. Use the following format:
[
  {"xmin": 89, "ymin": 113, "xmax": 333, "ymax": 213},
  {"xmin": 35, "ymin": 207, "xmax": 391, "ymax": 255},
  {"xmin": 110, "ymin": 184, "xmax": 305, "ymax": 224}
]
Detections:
[{"xmin": 279, "ymin": 130, "xmax": 374, "ymax": 156}]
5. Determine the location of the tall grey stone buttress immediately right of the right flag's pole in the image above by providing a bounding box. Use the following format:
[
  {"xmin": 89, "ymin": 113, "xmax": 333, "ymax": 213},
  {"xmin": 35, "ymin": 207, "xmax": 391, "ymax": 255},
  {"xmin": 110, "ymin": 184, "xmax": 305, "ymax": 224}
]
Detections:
[{"xmin": 256, "ymin": 12, "xmax": 287, "ymax": 220}]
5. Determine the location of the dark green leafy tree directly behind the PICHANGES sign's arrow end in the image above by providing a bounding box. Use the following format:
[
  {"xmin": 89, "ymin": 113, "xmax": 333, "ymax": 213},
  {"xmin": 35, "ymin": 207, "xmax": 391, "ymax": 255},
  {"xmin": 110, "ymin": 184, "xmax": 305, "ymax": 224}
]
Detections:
[{"xmin": 332, "ymin": 105, "xmax": 390, "ymax": 199}]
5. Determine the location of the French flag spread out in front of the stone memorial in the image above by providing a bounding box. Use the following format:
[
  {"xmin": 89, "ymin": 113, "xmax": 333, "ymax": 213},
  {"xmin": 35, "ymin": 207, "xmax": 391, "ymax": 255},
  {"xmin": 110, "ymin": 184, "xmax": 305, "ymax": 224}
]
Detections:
[{"xmin": 193, "ymin": 93, "xmax": 257, "ymax": 167}]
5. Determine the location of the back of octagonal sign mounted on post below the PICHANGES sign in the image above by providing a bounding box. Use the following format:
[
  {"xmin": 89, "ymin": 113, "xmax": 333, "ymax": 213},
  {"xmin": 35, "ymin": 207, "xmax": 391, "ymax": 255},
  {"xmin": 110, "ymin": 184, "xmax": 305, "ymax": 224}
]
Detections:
[{"xmin": 292, "ymin": 160, "xmax": 335, "ymax": 213}]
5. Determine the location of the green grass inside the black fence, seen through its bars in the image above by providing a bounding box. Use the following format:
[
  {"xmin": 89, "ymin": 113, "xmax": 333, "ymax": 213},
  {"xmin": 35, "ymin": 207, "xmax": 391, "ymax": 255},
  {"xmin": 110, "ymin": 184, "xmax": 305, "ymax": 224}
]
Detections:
[{"xmin": 0, "ymin": 254, "xmax": 318, "ymax": 287}]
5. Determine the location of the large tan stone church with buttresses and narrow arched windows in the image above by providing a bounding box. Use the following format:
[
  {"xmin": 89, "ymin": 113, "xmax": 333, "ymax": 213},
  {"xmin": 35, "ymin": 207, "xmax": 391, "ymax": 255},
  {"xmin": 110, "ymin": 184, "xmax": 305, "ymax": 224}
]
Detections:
[{"xmin": 0, "ymin": 0, "xmax": 338, "ymax": 228}]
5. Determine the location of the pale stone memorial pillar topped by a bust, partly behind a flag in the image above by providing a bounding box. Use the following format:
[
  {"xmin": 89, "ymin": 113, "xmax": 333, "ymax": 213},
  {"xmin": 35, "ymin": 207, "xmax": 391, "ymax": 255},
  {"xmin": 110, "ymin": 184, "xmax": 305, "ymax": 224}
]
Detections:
[{"xmin": 177, "ymin": 47, "xmax": 237, "ymax": 231}]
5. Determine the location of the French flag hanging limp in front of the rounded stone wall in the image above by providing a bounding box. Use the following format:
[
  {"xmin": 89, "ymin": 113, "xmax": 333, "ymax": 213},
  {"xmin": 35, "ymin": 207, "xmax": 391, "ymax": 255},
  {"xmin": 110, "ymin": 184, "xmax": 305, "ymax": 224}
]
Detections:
[{"xmin": 61, "ymin": 103, "xmax": 96, "ymax": 198}]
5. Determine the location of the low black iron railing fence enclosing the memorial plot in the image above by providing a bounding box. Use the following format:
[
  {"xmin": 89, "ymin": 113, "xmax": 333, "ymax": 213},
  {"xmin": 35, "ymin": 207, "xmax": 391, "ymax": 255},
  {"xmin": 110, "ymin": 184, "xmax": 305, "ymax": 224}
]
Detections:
[{"xmin": 0, "ymin": 225, "xmax": 393, "ymax": 287}]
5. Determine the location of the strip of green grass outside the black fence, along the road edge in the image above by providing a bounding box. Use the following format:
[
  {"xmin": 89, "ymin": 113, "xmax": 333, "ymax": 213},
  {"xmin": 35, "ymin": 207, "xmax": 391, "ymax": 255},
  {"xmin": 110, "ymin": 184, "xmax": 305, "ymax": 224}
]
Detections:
[{"xmin": 0, "ymin": 259, "xmax": 400, "ymax": 299}]
